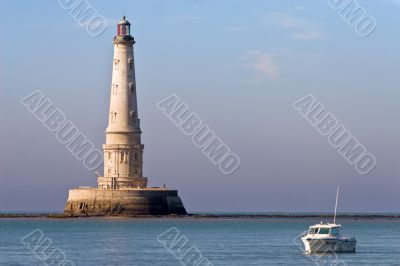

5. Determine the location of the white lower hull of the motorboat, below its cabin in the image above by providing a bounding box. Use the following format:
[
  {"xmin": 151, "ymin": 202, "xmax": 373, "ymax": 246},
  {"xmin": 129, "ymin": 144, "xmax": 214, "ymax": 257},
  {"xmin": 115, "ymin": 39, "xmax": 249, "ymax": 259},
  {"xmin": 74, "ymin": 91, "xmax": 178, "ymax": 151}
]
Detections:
[{"xmin": 301, "ymin": 237, "xmax": 357, "ymax": 253}]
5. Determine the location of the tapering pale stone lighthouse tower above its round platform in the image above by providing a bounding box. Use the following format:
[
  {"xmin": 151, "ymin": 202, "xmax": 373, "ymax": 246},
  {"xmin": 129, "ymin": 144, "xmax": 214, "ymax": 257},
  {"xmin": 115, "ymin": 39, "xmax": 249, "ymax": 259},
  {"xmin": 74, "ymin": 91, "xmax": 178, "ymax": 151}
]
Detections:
[{"xmin": 98, "ymin": 16, "xmax": 147, "ymax": 189}]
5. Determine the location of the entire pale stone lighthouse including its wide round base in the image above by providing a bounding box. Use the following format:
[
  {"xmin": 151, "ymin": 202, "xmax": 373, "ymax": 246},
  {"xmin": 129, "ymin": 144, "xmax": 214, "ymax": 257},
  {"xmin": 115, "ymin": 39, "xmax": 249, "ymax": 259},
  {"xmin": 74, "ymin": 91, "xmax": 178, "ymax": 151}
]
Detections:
[{"xmin": 64, "ymin": 16, "xmax": 186, "ymax": 216}]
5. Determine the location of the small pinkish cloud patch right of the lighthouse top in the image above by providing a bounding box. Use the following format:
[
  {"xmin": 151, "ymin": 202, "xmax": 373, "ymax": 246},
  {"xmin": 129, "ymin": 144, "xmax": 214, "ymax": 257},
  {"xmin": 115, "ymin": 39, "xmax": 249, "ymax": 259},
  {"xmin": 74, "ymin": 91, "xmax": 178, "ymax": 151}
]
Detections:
[{"xmin": 242, "ymin": 51, "xmax": 279, "ymax": 80}]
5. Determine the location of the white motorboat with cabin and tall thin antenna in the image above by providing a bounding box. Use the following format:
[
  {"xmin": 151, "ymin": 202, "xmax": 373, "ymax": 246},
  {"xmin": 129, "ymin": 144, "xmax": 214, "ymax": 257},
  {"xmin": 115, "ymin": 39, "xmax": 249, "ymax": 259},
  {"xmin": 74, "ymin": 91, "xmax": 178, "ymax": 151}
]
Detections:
[{"xmin": 301, "ymin": 187, "xmax": 357, "ymax": 253}]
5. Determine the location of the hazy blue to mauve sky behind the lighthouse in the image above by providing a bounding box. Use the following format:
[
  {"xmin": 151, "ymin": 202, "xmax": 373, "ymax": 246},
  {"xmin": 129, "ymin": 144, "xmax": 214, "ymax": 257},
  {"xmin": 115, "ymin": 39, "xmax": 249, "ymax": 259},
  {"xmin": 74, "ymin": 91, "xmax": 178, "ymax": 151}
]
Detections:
[{"xmin": 0, "ymin": 0, "xmax": 400, "ymax": 212}]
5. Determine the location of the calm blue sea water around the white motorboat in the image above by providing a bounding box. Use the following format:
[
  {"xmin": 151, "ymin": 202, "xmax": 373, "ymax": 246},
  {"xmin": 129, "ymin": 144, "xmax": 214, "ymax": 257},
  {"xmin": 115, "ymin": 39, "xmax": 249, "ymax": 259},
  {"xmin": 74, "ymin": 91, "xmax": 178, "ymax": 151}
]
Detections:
[{"xmin": 0, "ymin": 218, "xmax": 400, "ymax": 266}]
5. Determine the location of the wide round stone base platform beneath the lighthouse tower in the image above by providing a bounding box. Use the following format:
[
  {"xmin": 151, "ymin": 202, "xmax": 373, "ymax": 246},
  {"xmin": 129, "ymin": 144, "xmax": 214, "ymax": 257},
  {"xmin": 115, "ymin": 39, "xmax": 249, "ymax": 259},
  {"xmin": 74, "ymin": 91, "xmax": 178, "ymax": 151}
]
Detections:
[{"xmin": 64, "ymin": 187, "xmax": 187, "ymax": 217}]
